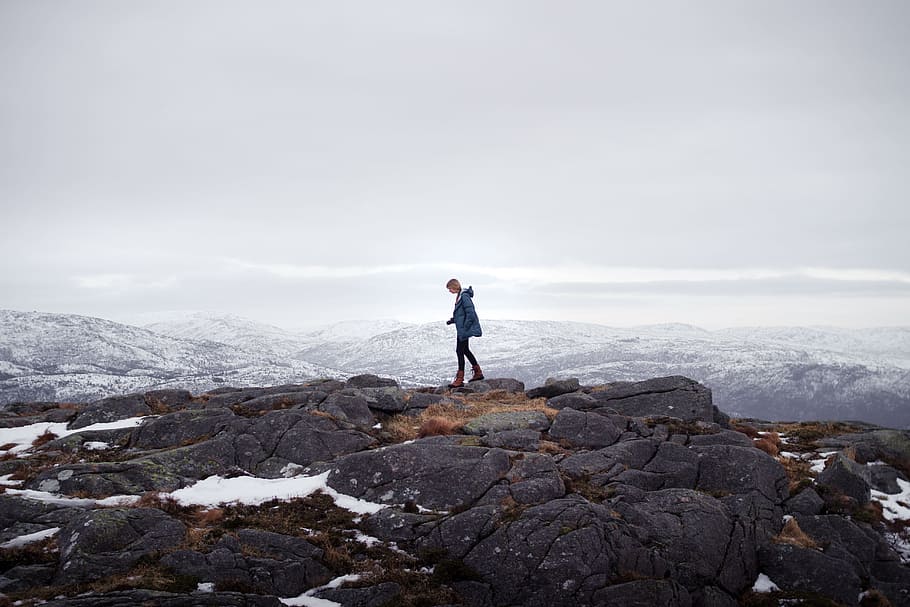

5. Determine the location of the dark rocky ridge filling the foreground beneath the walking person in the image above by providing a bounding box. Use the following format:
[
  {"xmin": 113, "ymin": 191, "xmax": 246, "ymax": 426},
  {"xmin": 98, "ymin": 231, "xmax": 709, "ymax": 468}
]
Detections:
[{"xmin": 0, "ymin": 375, "xmax": 910, "ymax": 607}]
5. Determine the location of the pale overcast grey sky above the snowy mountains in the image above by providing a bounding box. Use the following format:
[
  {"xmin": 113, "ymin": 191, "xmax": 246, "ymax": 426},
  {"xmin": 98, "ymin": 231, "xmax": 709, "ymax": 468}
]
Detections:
[{"xmin": 0, "ymin": 0, "xmax": 910, "ymax": 328}]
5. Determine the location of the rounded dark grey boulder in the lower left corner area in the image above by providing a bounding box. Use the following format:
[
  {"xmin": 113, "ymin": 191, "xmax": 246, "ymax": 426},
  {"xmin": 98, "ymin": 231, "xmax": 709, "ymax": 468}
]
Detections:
[{"xmin": 56, "ymin": 508, "xmax": 186, "ymax": 584}]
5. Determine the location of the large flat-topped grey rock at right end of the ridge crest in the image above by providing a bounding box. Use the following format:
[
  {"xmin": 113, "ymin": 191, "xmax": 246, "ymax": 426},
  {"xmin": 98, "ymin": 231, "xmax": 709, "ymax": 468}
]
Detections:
[{"xmin": 591, "ymin": 376, "xmax": 716, "ymax": 422}]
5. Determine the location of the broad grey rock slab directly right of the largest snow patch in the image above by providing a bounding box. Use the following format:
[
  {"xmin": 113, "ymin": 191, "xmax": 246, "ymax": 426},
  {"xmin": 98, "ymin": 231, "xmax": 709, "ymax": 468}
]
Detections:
[{"xmin": 328, "ymin": 439, "xmax": 511, "ymax": 510}]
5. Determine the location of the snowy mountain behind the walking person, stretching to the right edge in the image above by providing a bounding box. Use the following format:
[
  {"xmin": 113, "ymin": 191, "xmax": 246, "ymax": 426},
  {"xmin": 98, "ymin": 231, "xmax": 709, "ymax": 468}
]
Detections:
[{"xmin": 297, "ymin": 321, "xmax": 910, "ymax": 427}]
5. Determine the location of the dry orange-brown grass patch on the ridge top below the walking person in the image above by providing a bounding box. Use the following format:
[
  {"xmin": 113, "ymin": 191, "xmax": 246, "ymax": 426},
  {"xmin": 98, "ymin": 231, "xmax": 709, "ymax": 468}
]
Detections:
[{"xmin": 384, "ymin": 390, "xmax": 558, "ymax": 442}]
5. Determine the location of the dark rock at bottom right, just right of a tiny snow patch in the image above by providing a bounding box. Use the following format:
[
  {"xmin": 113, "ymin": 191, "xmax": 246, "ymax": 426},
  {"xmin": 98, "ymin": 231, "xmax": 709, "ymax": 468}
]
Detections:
[{"xmin": 759, "ymin": 543, "xmax": 863, "ymax": 605}]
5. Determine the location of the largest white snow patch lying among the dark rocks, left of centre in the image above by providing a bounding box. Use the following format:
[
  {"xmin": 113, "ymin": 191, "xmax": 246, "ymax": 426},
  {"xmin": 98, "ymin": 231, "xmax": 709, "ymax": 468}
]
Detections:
[{"xmin": 170, "ymin": 472, "xmax": 385, "ymax": 514}]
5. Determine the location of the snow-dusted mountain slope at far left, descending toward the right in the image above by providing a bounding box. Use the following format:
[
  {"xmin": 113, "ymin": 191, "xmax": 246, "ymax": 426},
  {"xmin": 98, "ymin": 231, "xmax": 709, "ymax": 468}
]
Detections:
[{"xmin": 0, "ymin": 310, "xmax": 343, "ymax": 404}]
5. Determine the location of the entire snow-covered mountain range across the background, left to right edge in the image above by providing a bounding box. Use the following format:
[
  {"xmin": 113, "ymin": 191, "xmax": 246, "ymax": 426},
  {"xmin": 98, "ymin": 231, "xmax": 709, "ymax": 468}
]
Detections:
[{"xmin": 0, "ymin": 311, "xmax": 910, "ymax": 428}]
